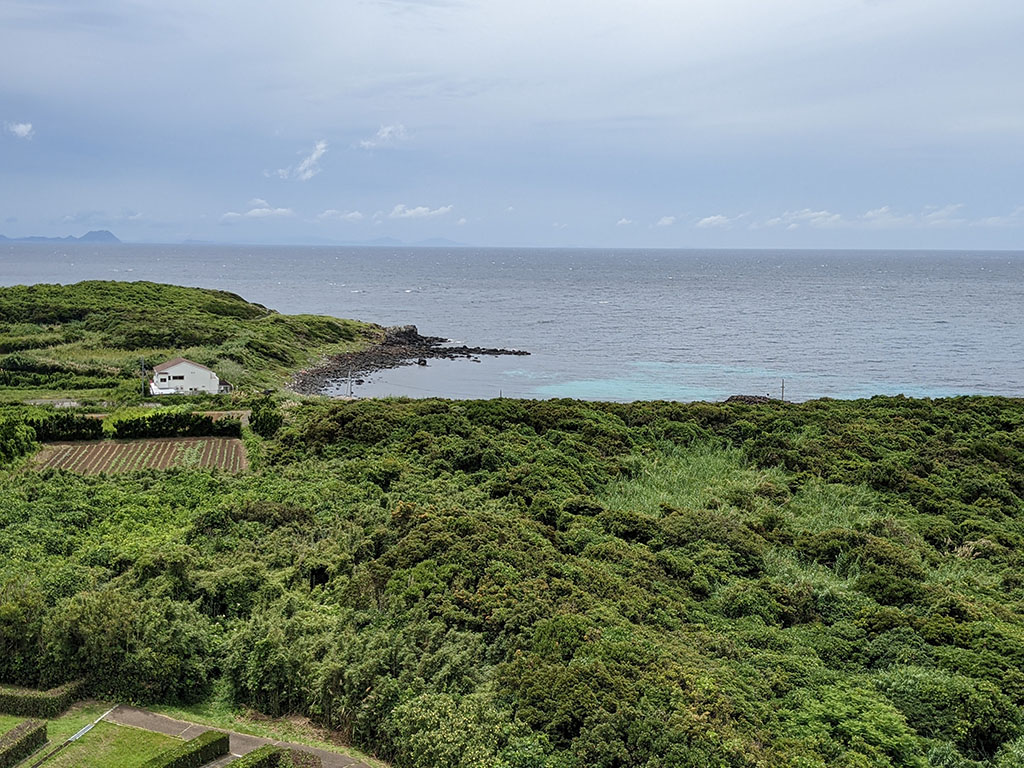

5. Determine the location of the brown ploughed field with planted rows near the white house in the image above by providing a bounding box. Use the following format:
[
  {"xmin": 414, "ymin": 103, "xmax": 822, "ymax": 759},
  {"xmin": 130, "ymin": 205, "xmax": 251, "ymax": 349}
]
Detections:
[{"xmin": 34, "ymin": 437, "xmax": 248, "ymax": 475}]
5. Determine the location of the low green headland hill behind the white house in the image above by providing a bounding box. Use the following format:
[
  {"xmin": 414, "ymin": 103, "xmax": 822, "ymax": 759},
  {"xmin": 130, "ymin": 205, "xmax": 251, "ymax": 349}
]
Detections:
[{"xmin": 0, "ymin": 281, "xmax": 380, "ymax": 402}]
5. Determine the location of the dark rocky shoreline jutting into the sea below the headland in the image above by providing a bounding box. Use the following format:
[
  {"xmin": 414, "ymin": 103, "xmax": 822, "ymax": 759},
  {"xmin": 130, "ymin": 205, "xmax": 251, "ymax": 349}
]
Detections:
[{"xmin": 289, "ymin": 326, "xmax": 529, "ymax": 394}]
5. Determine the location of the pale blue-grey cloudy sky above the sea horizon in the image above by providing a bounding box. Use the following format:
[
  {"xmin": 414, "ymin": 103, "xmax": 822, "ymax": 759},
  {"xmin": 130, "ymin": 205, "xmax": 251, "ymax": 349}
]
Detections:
[{"xmin": 0, "ymin": 0, "xmax": 1024, "ymax": 249}]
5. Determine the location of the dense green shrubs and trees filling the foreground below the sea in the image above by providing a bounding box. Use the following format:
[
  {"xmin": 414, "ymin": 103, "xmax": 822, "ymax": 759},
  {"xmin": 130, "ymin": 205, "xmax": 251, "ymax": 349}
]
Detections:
[{"xmin": 0, "ymin": 397, "xmax": 1024, "ymax": 768}]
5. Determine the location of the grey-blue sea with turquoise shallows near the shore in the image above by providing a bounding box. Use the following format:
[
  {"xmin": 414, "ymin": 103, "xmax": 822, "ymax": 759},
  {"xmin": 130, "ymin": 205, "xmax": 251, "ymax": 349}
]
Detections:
[{"xmin": 0, "ymin": 244, "xmax": 1024, "ymax": 400}]
